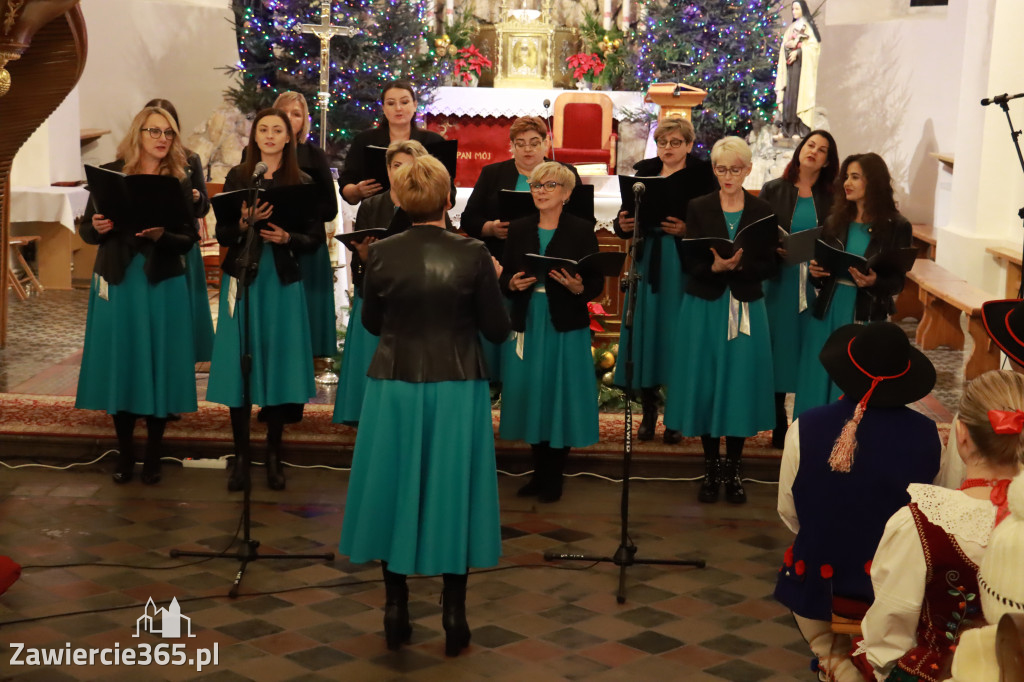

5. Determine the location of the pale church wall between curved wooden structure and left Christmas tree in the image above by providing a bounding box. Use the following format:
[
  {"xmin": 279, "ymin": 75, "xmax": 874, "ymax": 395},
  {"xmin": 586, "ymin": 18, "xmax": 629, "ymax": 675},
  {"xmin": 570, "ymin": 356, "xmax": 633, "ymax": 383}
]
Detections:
[{"xmin": 79, "ymin": 0, "xmax": 238, "ymax": 164}]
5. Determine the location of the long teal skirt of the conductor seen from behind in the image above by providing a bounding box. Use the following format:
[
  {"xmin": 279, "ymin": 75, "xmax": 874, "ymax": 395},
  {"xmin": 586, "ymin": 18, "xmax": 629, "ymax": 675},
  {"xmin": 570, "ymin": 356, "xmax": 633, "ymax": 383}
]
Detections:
[{"xmin": 339, "ymin": 379, "xmax": 502, "ymax": 576}]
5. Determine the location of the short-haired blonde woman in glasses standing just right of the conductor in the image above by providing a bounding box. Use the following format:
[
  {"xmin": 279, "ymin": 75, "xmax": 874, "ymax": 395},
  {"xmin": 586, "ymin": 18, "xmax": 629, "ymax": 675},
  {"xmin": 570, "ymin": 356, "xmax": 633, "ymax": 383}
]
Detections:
[{"xmin": 500, "ymin": 162, "xmax": 604, "ymax": 502}]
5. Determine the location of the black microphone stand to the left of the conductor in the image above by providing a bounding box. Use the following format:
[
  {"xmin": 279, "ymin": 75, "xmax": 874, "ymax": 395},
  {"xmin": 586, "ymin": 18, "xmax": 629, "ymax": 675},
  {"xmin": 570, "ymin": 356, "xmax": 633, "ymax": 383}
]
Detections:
[{"xmin": 170, "ymin": 175, "xmax": 334, "ymax": 599}]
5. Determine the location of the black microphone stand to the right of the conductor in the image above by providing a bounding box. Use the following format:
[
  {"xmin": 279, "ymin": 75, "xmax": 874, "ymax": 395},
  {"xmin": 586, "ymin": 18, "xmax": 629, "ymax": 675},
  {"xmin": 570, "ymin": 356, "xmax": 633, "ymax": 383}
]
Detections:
[{"xmin": 544, "ymin": 184, "xmax": 707, "ymax": 604}]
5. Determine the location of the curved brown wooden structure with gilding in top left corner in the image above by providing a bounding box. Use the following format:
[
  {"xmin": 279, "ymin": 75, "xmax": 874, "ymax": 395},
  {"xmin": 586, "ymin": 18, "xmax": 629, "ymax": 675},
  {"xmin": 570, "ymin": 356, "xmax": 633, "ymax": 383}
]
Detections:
[{"xmin": 0, "ymin": 0, "xmax": 87, "ymax": 348}]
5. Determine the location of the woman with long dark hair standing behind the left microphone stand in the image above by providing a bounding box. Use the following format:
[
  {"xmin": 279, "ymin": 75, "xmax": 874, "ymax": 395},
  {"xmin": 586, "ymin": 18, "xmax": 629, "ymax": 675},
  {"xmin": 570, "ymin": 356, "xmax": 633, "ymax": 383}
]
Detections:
[{"xmin": 206, "ymin": 109, "xmax": 323, "ymax": 491}]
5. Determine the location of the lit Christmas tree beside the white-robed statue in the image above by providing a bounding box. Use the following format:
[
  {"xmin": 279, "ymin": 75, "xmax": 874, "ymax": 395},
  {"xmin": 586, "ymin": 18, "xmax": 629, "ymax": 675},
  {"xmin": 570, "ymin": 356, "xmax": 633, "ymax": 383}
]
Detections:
[{"xmin": 636, "ymin": 0, "xmax": 784, "ymax": 154}]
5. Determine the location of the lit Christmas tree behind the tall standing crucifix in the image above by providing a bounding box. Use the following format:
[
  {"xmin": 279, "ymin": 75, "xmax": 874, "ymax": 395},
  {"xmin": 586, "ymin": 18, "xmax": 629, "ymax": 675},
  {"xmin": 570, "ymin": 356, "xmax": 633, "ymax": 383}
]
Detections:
[{"xmin": 226, "ymin": 0, "xmax": 442, "ymax": 154}]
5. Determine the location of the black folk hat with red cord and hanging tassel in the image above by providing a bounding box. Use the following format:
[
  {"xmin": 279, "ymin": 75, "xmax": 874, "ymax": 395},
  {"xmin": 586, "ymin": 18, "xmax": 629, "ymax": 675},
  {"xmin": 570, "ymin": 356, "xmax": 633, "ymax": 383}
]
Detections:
[{"xmin": 818, "ymin": 322, "xmax": 935, "ymax": 472}]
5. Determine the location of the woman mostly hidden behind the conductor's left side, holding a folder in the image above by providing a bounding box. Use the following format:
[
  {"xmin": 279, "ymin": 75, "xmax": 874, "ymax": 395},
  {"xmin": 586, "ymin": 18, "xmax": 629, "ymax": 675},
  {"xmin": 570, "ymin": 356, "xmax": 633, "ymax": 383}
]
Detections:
[{"xmin": 333, "ymin": 139, "xmax": 427, "ymax": 426}]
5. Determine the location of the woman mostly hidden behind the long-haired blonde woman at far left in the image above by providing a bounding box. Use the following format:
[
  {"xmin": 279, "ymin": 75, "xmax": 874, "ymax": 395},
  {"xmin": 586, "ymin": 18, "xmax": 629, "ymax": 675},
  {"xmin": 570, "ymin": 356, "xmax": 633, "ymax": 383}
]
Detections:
[{"xmin": 145, "ymin": 98, "xmax": 213, "ymax": 360}]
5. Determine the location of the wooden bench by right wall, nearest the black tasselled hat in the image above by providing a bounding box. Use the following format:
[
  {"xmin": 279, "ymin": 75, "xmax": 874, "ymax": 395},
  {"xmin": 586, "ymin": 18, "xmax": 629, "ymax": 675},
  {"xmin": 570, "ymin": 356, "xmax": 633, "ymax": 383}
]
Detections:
[{"xmin": 907, "ymin": 260, "xmax": 999, "ymax": 380}]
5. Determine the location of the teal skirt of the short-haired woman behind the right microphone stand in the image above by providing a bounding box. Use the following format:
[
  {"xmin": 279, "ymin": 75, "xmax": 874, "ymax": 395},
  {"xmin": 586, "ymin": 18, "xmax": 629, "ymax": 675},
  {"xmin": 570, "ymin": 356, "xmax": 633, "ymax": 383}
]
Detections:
[{"xmin": 614, "ymin": 232, "xmax": 686, "ymax": 388}]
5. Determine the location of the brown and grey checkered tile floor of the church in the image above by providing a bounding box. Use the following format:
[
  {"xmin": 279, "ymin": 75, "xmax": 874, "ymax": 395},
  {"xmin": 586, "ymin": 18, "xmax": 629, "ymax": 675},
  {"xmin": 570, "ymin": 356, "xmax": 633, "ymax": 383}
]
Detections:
[{"xmin": 0, "ymin": 292, "xmax": 963, "ymax": 682}]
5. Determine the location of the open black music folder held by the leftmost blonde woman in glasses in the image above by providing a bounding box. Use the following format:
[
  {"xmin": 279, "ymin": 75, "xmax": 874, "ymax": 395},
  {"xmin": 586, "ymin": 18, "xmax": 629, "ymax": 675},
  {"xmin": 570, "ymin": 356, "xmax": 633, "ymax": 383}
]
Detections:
[{"xmin": 85, "ymin": 164, "xmax": 194, "ymax": 235}]
